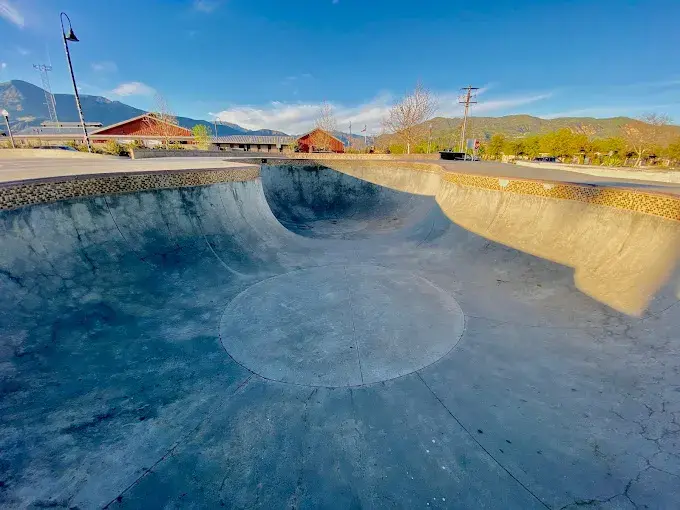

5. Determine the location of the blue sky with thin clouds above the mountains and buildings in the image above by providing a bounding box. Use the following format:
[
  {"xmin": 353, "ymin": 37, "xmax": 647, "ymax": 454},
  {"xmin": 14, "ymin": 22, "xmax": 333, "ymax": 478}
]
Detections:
[{"xmin": 0, "ymin": 0, "xmax": 680, "ymax": 132}]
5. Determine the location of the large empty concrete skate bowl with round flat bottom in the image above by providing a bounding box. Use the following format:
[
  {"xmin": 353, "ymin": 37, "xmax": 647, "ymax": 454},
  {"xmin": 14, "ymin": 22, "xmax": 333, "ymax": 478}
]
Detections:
[{"xmin": 0, "ymin": 163, "xmax": 680, "ymax": 509}]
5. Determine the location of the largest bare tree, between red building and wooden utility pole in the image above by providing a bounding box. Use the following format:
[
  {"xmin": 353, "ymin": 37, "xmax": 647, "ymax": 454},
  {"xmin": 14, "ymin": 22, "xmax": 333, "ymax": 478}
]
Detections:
[{"xmin": 383, "ymin": 83, "xmax": 437, "ymax": 154}]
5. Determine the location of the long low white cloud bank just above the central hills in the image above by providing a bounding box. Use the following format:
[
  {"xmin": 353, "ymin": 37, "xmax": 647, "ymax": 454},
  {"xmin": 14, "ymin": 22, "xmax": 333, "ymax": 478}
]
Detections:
[{"xmin": 210, "ymin": 87, "xmax": 551, "ymax": 134}]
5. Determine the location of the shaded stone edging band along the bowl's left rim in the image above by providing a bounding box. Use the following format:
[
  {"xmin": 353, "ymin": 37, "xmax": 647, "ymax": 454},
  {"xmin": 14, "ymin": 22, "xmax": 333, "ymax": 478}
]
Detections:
[{"xmin": 0, "ymin": 166, "xmax": 260, "ymax": 211}]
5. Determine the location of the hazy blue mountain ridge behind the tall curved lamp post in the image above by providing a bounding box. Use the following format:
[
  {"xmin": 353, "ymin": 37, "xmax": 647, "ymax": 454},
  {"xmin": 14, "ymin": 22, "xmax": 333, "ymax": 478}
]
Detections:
[{"xmin": 0, "ymin": 80, "xmax": 255, "ymax": 136}]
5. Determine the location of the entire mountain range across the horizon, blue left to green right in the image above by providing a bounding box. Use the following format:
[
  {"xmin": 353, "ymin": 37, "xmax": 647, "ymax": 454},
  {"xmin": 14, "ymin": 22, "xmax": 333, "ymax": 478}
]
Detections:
[{"xmin": 0, "ymin": 80, "xmax": 680, "ymax": 146}]
